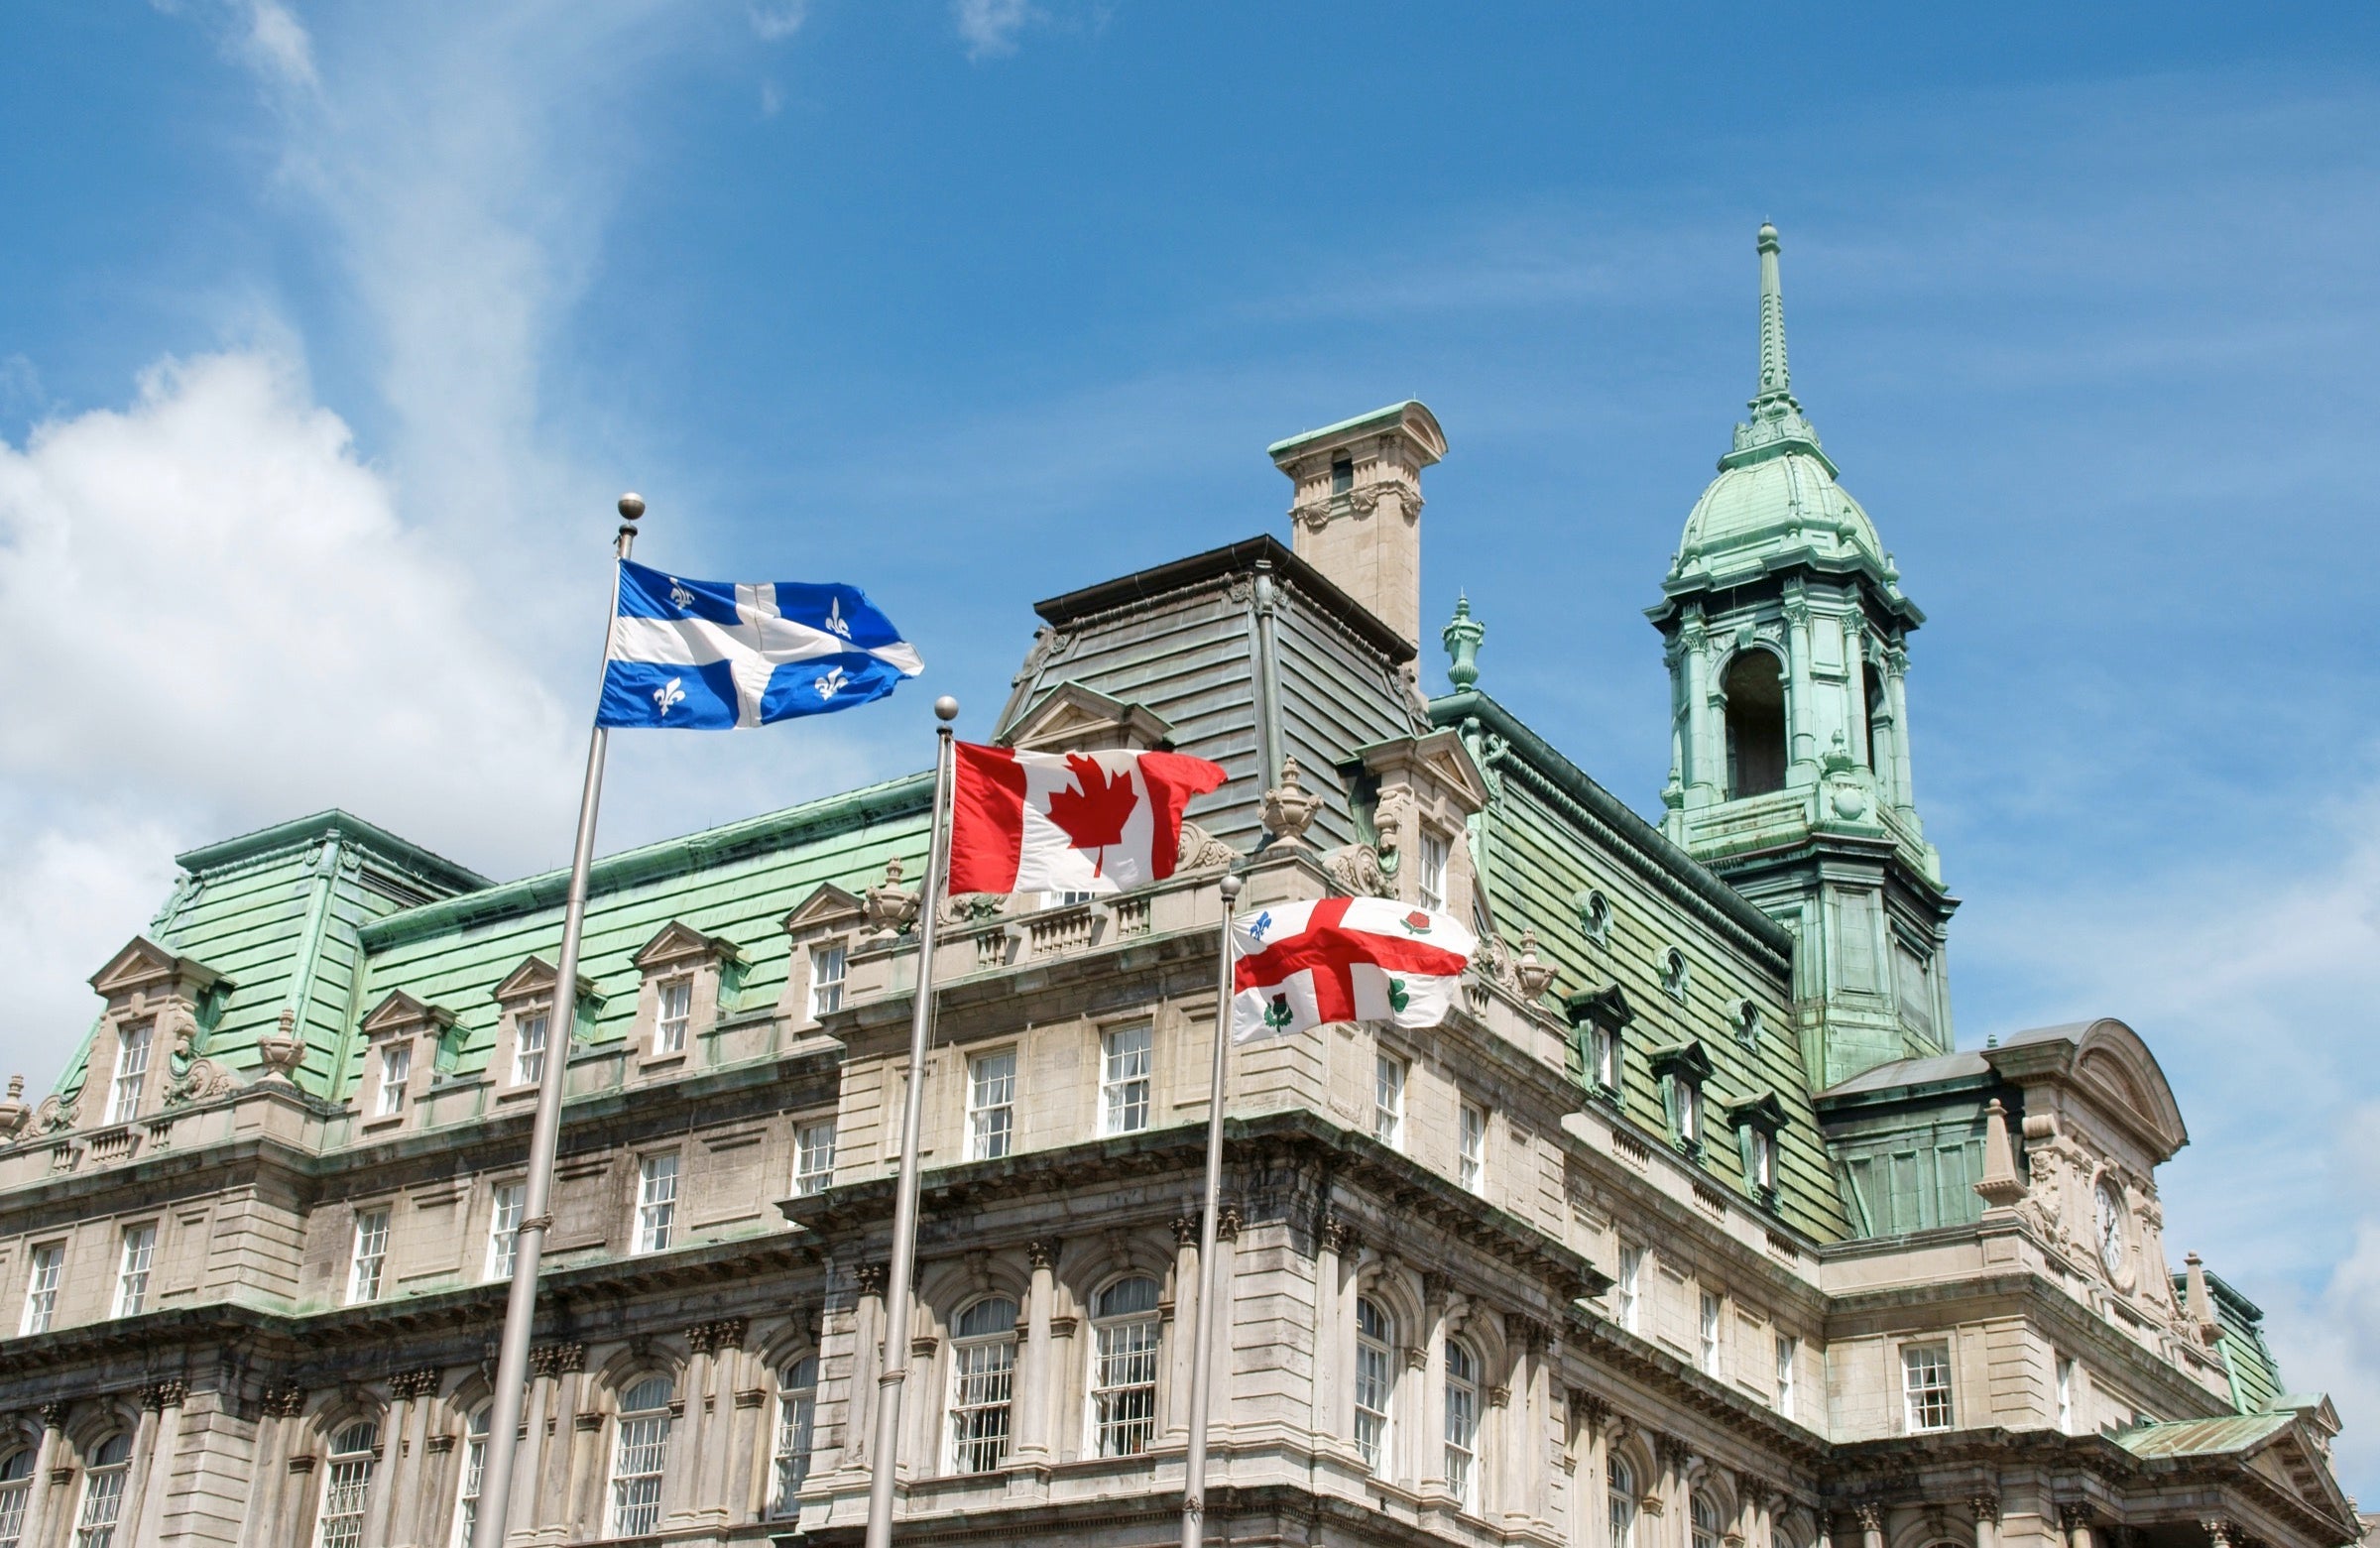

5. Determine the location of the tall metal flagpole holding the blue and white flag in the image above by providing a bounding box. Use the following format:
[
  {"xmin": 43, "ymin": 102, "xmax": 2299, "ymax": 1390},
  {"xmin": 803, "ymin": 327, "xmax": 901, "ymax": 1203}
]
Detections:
[{"xmin": 471, "ymin": 496, "xmax": 645, "ymax": 1548}]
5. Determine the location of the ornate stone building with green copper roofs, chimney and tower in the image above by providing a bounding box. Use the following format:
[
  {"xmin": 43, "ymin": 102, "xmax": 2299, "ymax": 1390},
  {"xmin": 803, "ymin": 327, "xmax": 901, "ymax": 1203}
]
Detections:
[{"xmin": 0, "ymin": 231, "xmax": 2356, "ymax": 1548}]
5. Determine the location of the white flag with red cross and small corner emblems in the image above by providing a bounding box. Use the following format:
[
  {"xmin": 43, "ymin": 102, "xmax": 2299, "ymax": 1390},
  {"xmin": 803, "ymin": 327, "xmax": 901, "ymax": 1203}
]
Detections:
[{"xmin": 1231, "ymin": 897, "xmax": 1478, "ymax": 1043}]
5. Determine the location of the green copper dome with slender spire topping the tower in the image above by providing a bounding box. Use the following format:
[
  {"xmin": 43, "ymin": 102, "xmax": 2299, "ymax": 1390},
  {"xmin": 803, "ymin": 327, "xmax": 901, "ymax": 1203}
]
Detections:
[{"xmin": 1668, "ymin": 224, "xmax": 1899, "ymax": 591}]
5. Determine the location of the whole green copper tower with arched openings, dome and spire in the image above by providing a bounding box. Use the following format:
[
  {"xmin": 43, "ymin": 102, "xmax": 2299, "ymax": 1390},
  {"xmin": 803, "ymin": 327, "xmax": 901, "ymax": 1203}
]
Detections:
[{"xmin": 1649, "ymin": 224, "xmax": 1957, "ymax": 1086}]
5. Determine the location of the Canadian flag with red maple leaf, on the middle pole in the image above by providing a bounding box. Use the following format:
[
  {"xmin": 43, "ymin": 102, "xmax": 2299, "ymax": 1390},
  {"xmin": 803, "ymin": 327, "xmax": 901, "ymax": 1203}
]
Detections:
[{"xmin": 950, "ymin": 741, "xmax": 1224, "ymax": 893}]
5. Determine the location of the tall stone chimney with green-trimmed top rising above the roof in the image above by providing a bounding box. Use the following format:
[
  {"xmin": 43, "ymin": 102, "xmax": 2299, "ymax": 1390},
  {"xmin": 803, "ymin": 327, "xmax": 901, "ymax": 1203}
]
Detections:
[{"xmin": 1266, "ymin": 403, "xmax": 1447, "ymax": 646}]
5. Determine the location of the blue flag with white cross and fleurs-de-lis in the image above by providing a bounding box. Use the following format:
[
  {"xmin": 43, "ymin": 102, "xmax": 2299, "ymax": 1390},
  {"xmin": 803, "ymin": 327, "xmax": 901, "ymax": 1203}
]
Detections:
[{"xmin": 595, "ymin": 559, "xmax": 926, "ymax": 731}]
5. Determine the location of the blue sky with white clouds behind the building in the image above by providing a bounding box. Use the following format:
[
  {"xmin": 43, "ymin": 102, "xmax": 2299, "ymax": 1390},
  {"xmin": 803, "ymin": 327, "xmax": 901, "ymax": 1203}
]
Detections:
[{"xmin": 0, "ymin": 0, "xmax": 2380, "ymax": 1495}]
